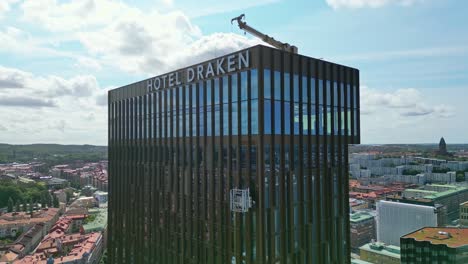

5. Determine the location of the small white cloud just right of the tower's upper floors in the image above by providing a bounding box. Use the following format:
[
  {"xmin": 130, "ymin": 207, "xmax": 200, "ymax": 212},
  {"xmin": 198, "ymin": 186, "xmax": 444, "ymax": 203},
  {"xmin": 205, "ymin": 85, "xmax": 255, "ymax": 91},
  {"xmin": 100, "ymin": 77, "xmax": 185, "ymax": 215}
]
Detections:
[{"xmin": 360, "ymin": 86, "xmax": 454, "ymax": 118}]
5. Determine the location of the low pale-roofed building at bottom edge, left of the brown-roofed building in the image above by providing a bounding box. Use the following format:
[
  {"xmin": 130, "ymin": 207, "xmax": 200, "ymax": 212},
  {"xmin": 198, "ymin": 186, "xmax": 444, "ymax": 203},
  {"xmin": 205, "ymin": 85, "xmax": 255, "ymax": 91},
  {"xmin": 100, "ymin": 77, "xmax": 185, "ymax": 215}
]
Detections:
[{"xmin": 359, "ymin": 242, "xmax": 400, "ymax": 264}]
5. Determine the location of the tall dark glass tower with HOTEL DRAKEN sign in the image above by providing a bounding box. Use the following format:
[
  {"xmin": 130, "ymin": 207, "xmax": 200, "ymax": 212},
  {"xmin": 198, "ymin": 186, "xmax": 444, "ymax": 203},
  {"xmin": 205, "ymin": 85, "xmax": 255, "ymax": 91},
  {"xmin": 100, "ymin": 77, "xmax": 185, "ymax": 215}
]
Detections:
[{"xmin": 108, "ymin": 45, "xmax": 360, "ymax": 264}]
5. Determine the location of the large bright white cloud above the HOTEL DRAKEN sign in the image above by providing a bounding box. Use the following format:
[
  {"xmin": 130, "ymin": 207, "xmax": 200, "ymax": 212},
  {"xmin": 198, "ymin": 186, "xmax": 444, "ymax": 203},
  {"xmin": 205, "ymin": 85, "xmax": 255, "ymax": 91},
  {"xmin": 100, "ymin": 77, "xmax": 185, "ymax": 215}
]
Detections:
[{"xmin": 18, "ymin": 0, "xmax": 260, "ymax": 75}]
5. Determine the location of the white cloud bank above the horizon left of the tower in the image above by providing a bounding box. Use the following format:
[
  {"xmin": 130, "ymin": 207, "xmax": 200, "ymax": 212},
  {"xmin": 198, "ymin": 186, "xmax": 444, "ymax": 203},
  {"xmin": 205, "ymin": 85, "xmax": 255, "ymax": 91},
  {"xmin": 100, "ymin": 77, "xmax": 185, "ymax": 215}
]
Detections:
[{"xmin": 0, "ymin": 66, "xmax": 108, "ymax": 144}]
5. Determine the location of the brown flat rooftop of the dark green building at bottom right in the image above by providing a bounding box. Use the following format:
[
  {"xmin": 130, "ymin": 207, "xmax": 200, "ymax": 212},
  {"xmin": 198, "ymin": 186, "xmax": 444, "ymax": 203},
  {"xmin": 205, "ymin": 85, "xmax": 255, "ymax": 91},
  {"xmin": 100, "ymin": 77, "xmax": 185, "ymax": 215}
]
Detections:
[{"xmin": 403, "ymin": 227, "xmax": 468, "ymax": 248}]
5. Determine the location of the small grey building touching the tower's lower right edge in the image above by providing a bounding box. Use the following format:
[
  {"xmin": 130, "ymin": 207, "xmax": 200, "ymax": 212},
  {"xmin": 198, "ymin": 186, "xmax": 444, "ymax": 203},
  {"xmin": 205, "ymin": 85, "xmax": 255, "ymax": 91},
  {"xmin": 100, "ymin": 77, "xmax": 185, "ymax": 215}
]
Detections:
[{"xmin": 349, "ymin": 212, "xmax": 376, "ymax": 250}]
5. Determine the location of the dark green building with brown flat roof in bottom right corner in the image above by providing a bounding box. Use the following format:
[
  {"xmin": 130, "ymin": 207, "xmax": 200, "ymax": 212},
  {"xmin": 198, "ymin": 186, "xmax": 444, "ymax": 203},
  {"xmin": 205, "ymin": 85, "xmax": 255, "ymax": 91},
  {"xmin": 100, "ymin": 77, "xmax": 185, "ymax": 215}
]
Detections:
[{"xmin": 401, "ymin": 227, "xmax": 468, "ymax": 264}]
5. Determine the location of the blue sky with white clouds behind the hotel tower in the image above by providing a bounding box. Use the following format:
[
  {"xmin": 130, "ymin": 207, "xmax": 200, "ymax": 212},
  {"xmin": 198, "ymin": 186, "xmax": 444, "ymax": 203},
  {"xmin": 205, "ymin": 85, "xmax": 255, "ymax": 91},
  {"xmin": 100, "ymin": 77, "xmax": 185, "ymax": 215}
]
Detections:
[{"xmin": 0, "ymin": 0, "xmax": 468, "ymax": 145}]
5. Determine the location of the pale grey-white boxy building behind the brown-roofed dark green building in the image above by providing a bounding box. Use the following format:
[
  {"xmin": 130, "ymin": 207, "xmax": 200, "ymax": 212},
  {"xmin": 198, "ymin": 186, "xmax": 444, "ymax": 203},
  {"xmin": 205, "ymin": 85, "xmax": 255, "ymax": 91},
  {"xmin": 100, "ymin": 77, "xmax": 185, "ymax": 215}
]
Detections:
[{"xmin": 377, "ymin": 201, "xmax": 443, "ymax": 246}]
